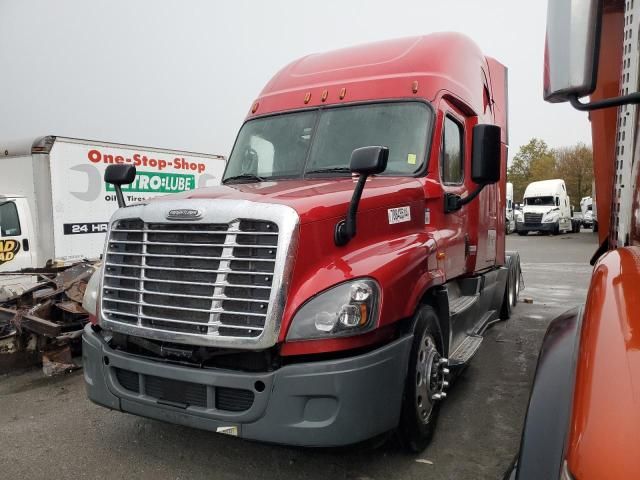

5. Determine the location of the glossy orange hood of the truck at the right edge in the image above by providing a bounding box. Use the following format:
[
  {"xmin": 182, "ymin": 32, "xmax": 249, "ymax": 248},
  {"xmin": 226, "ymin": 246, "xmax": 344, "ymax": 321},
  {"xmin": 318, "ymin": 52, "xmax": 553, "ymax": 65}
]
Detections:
[{"xmin": 567, "ymin": 247, "xmax": 640, "ymax": 480}]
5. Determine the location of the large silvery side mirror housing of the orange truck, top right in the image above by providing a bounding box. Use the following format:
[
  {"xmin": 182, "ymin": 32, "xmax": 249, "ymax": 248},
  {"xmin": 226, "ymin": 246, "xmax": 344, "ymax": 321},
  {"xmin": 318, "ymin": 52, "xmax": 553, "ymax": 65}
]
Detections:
[{"xmin": 544, "ymin": 0, "xmax": 602, "ymax": 103}]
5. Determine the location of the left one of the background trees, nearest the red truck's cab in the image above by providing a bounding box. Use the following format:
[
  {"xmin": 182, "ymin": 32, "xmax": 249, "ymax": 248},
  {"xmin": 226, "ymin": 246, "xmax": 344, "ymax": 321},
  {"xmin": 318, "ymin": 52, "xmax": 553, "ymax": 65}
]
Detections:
[{"xmin": 507, "ymin": 138, "xmax": 556, "ymax": 202}]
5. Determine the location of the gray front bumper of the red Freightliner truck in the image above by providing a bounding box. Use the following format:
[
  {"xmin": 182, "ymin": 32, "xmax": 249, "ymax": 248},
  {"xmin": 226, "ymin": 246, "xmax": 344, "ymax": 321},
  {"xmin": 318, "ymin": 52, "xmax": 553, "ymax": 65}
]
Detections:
[{"xmin": 82, "ymin": 325, "xmax": 412, "ymax": 446}]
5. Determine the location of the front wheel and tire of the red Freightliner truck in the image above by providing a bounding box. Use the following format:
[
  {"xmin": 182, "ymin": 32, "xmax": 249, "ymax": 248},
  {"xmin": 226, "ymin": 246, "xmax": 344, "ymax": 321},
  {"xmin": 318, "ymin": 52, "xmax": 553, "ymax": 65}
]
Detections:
[{"xmin": 397, "ymin": 305, "xmax": 443, "ymax": 452}]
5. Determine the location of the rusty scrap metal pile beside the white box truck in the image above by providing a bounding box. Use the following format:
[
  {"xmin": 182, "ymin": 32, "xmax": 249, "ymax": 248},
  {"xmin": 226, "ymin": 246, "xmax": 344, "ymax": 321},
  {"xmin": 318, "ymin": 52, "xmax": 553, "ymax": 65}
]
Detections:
[{"xmin": 0, "ymin": 261, "xmax": 98, "ymax": 376}]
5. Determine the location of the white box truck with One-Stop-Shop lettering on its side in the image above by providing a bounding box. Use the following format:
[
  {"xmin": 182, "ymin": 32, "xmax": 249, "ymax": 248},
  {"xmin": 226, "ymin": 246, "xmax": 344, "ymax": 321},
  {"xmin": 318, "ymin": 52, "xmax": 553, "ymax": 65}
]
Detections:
[{"xmin": 0, "ymin": 136, "xmax": 225, "ymax": 288}]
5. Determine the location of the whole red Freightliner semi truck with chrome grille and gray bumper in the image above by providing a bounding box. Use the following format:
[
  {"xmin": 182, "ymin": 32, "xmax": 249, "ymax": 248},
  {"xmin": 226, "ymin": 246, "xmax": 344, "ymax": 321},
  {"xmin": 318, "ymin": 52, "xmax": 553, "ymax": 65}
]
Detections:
[{"xmin": 83, "ymin": 33, "xmax": 519, "ymax": 450}]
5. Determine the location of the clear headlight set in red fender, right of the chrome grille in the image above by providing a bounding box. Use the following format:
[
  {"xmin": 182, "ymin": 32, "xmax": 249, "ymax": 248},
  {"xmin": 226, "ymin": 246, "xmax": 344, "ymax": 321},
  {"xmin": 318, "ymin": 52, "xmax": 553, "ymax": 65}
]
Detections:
[{"xmin": 287, "ymin": 279, "xmax": 380, "ymax": 340}]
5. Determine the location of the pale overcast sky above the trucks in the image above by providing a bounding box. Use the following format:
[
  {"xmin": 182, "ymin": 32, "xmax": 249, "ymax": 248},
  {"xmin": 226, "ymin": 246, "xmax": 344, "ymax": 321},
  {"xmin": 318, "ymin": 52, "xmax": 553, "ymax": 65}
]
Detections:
[{"xmin": 0, "ymin": 0, "xmax": 590, "ymax": 160}]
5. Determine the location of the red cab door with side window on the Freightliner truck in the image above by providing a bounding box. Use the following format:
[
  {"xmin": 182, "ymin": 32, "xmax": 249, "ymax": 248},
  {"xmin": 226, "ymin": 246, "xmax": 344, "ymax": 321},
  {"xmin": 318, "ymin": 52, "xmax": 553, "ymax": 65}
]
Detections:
[{"xmin": 439, "ymin": 105, "xmax": 472, "ymax": 278}]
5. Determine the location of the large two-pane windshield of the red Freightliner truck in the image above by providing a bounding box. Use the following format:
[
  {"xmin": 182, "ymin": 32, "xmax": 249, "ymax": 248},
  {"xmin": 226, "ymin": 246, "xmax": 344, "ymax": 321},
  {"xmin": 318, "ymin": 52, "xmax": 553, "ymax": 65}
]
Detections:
[{"xmin": 223, "ymin": 102, "xmax": 431, "ymax": 183}]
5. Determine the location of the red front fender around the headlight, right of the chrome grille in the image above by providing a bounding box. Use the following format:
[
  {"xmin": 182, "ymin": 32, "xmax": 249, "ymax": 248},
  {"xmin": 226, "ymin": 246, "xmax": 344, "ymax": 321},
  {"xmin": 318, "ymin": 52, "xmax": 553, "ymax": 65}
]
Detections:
[{"xmin": 279, "ymin": 210, "xmax": 444, "ymax": 352}]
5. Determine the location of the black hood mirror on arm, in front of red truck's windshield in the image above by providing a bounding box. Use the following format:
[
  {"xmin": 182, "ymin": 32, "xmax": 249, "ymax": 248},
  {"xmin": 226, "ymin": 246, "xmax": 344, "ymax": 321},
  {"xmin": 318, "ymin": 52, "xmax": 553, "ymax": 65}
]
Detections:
[{"xmin": 333, "ymin": 146, "xmax": 389, "ymax": 246}]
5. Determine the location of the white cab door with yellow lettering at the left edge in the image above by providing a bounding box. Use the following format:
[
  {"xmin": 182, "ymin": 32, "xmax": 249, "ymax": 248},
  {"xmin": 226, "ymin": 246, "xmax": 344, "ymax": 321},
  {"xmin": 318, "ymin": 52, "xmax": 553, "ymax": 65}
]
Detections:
[{"xmin": 0, "ymin": 198, "xmax": 33, "ymax": 274}]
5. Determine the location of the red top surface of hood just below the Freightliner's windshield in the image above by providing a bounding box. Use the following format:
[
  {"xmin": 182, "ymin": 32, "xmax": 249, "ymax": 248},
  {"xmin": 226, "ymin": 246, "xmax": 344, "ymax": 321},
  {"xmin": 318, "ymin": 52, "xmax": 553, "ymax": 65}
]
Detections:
[{"xmin": 150, "ymin": 177, "xmax": 424, "ymax": 223}]
